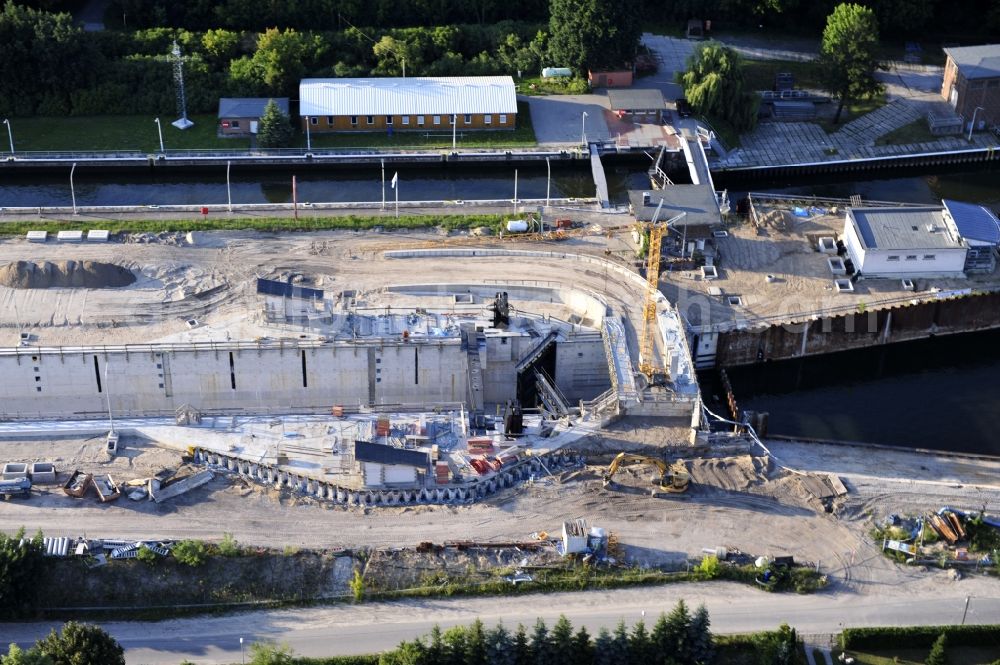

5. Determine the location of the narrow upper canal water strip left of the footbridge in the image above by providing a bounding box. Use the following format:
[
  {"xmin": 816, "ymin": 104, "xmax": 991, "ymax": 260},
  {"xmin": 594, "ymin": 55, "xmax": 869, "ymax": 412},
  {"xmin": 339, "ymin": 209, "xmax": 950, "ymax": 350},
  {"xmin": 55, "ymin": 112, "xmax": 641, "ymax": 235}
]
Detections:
[{"xmin": 0, "ymin": 156, "xmax": 660, "ymax": 208}]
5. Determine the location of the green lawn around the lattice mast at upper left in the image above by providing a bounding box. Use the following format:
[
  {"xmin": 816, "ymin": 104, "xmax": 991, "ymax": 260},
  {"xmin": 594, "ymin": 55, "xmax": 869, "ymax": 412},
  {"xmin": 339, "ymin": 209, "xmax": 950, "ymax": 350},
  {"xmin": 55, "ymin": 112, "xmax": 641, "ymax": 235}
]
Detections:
[{"xmin": 10, "ymin": 115, "xmax": 250, "ymax": 153}]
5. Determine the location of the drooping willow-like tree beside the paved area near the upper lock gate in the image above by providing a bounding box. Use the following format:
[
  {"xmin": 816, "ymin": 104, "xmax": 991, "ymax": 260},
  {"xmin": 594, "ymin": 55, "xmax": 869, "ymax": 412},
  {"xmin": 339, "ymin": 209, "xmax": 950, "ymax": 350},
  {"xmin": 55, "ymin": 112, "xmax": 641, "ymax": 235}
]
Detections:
[{"xmin": 677, "ymin": 42, "xmax": 760, "ymax": 132}]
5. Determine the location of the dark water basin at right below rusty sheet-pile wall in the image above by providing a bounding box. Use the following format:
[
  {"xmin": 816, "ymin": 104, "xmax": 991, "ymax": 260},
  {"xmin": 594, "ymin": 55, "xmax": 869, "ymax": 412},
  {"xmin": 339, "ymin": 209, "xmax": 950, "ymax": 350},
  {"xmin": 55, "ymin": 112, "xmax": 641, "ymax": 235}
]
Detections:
[{"xmin": 700, "ymin": 330, "xmax": 1000, "ymax": 456}]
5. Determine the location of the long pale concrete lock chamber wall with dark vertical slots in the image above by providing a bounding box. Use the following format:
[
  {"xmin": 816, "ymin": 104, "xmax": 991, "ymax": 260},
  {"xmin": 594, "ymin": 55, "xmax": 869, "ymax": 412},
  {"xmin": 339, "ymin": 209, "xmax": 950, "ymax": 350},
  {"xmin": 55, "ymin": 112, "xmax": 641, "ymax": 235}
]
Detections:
[{"xmin": 0, "ymin": 340, "xmax": 468, "ymax": 418}]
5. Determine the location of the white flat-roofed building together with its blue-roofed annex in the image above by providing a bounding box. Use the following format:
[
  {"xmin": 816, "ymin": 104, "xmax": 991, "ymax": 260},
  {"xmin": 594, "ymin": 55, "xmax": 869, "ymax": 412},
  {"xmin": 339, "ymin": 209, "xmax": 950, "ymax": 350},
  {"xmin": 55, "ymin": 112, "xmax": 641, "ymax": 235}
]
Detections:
[{"xmin": 843, "ymin": 201, "xmax": 1000, "ymax": 278}]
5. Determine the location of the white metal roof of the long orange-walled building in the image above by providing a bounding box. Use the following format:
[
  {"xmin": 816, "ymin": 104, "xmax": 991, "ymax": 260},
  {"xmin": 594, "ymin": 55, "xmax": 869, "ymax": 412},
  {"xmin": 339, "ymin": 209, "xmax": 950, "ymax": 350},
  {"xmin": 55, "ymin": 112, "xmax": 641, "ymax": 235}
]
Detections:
[{"xmin": 299, "ymin": 76, "xmax": 517, "ymax": 116}]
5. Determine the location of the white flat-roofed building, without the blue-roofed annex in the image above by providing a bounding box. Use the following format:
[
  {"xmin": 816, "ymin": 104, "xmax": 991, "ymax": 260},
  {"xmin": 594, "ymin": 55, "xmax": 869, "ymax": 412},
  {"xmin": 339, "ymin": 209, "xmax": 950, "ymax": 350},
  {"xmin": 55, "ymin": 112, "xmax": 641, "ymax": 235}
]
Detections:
[{"xmin": 843, "ymin": 206, "xmax": 969, "ymax": 278}]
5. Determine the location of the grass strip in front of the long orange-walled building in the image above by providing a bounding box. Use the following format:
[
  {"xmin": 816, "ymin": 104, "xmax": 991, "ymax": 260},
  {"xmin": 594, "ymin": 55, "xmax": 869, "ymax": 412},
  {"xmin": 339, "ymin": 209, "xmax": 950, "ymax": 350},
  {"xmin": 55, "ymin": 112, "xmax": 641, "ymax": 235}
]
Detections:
[{"xmin": 295, "ymin": 102, "xmax": 538, "ymax": 150}]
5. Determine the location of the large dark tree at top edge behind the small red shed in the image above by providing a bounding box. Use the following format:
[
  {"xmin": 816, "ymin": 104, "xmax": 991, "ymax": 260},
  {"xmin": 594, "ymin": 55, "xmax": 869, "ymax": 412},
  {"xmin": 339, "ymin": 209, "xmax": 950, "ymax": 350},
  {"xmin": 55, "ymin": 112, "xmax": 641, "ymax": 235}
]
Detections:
[{"xmin": 549, "ymin": 0, "xmax": 642, "ymax": 75}]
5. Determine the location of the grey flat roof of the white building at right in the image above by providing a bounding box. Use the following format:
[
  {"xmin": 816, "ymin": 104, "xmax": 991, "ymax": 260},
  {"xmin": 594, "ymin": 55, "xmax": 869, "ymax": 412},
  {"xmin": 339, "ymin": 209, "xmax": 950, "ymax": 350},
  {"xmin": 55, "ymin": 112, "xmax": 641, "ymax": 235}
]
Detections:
[{"xmin": 848, "ymin": 206, "xmax": 962, "ymax": 251}]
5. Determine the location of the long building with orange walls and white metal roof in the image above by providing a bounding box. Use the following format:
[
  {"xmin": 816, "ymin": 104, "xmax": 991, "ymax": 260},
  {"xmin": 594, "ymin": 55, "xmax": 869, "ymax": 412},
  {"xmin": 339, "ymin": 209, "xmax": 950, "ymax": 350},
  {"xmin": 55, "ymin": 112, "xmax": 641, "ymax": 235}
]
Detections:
[{"xmin": 299, "ymin": 76, "xmax": 517, "ymax": 133}]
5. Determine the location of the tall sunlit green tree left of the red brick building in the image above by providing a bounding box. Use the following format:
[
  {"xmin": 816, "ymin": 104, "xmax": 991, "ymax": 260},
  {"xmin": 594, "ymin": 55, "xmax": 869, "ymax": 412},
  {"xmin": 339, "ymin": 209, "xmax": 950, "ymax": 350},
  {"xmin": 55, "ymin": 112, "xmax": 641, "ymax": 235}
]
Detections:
[{"xmin": 818, "ymin": 3, "xmax": 882, "ymax": 124}]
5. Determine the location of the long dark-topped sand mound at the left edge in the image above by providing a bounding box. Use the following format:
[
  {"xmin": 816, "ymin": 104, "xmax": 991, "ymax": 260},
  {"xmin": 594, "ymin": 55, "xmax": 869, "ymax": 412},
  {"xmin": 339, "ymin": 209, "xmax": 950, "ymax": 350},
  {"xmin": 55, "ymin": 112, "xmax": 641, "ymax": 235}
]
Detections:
[{"xmin": 0, "ymin": 261, "xmax": 135, "ymax": 289}]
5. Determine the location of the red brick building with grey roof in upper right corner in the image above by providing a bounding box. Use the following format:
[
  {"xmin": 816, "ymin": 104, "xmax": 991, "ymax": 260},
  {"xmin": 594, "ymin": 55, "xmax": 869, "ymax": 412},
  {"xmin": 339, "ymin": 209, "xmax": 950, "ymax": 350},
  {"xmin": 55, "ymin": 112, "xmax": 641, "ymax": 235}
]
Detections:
[{"xmin": 941, "ymin": 44, "xmax": 1000, "ymax": 129}]
